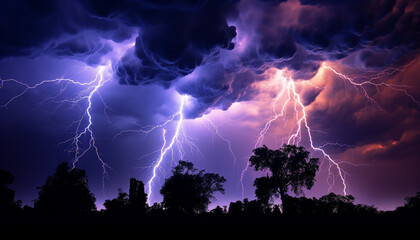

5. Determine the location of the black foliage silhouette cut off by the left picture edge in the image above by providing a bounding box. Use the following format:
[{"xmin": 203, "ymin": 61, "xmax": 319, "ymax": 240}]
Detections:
[{"xmin": 0, "ymin": 169, "xmax": 21, "ymax": 216}]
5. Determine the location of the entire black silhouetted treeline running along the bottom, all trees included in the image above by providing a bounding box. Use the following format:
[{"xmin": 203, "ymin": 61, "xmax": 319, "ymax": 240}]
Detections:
[{"xmin": 0, "ymin": 145, "xmax": 420, "ymax": 227}]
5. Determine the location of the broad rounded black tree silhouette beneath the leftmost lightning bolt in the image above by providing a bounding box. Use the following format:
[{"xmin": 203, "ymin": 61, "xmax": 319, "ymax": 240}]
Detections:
[{"xmin": 34, "ymin": 163, "xmax": 96, "ymax": 215}]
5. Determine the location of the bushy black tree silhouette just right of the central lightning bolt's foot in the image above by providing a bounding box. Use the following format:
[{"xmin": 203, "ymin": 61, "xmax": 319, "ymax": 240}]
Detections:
[{"xmin": 160, "ymin": 161, "xmax": 226, "ymax": 213}]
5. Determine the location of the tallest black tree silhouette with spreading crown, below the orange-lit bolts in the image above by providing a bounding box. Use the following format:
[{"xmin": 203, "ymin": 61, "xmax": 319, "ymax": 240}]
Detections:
[{"xmin": 249, "ymin": 144, "xmax": 319, "ymax": 214}]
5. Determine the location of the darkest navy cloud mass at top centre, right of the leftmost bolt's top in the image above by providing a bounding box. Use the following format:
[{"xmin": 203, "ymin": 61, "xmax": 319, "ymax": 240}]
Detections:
[{"xmin": 99, "ymin": 1, "xmax": 236, "ymax": 87}]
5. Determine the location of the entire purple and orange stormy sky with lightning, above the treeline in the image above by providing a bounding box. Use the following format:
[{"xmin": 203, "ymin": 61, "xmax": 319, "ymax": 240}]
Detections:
[{"xmin": 0, "ymin": 0, "xmax": 420, "ymax": 210}]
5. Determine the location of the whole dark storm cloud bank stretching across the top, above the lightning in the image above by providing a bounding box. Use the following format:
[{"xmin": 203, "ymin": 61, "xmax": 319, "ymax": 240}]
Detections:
[{"xmin": 0, "ymin": 0, "xmax": 420, "ymax": 117}]
